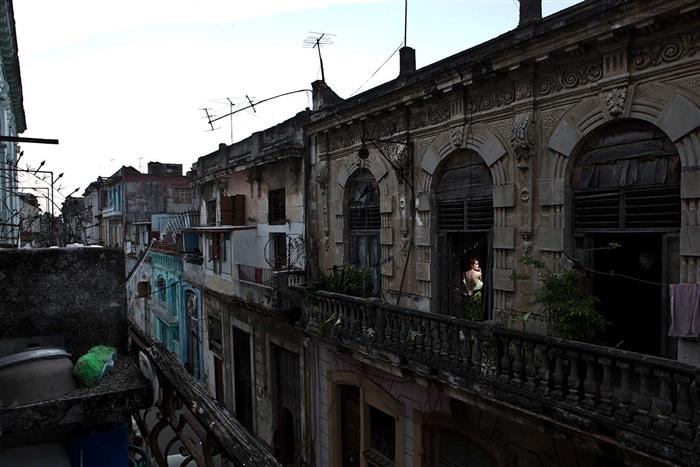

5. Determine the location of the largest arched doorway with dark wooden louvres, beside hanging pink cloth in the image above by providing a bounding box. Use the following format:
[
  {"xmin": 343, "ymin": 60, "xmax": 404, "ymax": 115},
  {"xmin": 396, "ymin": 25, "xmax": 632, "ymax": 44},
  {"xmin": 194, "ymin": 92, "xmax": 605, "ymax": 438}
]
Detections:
[{"xmin": 571, "ymin": 120, "xmax": 681, "ymax": 357}]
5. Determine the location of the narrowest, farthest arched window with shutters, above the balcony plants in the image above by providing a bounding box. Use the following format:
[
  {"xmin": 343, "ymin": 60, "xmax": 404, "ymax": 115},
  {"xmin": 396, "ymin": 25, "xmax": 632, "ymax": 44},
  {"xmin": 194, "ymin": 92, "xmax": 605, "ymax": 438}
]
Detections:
[{"xmin": 345, "ymin": 169, "xmax": 381, "ymax": 295}]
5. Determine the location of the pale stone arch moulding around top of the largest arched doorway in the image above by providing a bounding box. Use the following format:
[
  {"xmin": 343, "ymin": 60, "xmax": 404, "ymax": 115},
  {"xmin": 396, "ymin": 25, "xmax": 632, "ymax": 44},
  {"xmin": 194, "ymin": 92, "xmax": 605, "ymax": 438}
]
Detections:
[{"xmin": 542, "ymin": 83, "xmax": 700, "ymax": 166}]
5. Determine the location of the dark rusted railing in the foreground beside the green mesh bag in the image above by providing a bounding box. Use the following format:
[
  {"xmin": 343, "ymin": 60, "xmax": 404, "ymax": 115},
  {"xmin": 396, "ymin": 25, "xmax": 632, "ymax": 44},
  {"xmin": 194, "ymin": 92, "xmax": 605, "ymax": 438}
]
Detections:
[{"xmin": 129, "ymin": 325, "xmax": 280, "ymax": 467}]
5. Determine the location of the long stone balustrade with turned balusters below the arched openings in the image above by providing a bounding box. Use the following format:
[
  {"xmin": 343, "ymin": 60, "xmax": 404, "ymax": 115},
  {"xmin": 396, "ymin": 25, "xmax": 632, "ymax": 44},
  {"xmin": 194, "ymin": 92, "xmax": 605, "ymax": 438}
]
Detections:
[{"xmin": 304, "ymin": 292, "xmax": 700, "ymax": 465}]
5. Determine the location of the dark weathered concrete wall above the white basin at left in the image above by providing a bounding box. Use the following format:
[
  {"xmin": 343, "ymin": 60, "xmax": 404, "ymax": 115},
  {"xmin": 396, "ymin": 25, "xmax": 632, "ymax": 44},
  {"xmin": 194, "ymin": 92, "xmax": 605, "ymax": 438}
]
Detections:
[{"xmin": 0, "ymin": 248, "xmax": 127, "ymax": 355}]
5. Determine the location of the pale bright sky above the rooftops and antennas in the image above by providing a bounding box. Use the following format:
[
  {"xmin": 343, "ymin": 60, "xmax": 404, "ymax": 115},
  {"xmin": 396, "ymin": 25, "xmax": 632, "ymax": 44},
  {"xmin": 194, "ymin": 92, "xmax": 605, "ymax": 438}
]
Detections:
[{"xmin": 14, "ymin": 0, "xmax": 580, "ymax": 204}]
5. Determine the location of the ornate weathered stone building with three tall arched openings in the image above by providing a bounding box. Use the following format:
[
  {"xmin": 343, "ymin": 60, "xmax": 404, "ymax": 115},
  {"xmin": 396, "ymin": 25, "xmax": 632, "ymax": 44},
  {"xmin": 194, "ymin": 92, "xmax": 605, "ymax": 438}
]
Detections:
[{"xmin": 305, "ymin": 0, "xmax": 700, "ymax": 466}]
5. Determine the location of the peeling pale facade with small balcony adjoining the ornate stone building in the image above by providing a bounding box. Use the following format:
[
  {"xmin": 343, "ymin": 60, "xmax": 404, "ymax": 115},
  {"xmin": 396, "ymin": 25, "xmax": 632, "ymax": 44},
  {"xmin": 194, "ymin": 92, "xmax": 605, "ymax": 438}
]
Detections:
[{"xmin": 189, "ymin": 110, "xmax": 311, "ymax": 465}]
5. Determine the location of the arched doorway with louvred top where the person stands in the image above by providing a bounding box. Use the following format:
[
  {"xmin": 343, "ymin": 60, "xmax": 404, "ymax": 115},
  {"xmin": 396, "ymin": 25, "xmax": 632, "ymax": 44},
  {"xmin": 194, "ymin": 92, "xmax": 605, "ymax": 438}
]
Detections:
[{"xmin": 433, "ymin": 150, "xmax": 493, "ymax": 320}]
